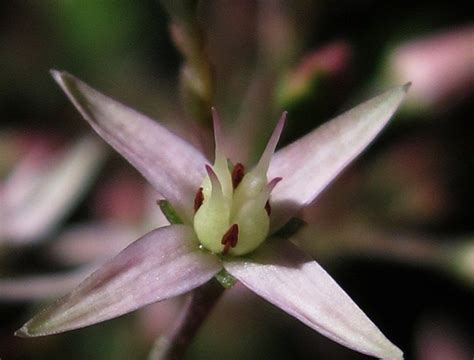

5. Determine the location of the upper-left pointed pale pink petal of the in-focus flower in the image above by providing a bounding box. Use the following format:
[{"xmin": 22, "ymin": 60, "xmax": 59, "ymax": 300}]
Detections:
[{"xmin": 52, "ymin": 70, "xmax": 207, "ymax": 222}]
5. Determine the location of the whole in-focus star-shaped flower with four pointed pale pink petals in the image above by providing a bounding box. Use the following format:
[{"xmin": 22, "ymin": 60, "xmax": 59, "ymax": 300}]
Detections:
[{"xmin": 16, "ymin": 71, "xmax": 408, "ymax": 359}]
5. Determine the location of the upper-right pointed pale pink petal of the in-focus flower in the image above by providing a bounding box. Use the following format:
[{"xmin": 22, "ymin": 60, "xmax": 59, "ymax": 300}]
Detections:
[{"xmin": 268, "ymin": 86, "xmax": 408, "ymax": 229}]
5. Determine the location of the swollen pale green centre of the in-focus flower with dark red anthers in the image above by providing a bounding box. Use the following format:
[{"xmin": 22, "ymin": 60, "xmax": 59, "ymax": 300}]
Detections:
[{"xmin": 194, "ymin": 162, "xmax": 279, "ymax": 255}]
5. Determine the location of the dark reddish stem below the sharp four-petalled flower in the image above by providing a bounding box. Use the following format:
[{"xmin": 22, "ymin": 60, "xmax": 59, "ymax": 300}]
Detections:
[{"xmin": 148, "ymin": 279, "xmax": 225, "ymax": 360}]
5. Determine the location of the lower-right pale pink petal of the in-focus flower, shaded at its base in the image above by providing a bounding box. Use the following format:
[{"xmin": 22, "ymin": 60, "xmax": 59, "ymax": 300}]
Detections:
[{"xmin": 224, "ymin": 242, "xmax": 403, "ymax": 359}]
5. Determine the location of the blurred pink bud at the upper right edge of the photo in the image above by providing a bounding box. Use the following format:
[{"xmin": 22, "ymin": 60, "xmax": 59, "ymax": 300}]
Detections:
[{"xmin": 387, "ymin": 26, "xmax": 474, "ymax": 110}]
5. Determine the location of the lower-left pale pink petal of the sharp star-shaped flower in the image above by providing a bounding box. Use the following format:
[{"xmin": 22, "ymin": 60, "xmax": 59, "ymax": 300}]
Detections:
[{"xmin": 17, "ymin": 225, "xmax": 222, "ymax": 337}]
